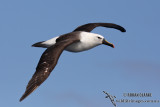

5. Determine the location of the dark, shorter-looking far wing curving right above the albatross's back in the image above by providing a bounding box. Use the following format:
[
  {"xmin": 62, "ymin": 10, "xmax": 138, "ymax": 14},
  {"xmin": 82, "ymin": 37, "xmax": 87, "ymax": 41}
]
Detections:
[{"xmin": 73, "ymin": 23, "xmax": 126, "ymax": 32}]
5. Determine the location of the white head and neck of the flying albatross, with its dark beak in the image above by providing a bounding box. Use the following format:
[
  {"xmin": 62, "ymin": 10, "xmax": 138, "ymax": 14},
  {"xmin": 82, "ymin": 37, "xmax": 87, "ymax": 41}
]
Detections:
[{"xmin": 81, "ymin": 32, "xmax": 114, "ymax": 48}]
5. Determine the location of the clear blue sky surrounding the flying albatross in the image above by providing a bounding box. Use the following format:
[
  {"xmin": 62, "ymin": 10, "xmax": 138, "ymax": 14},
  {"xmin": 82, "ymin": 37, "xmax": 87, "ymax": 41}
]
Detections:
[{"xmin": 0, "ymin": 0, "xmax": 160, "ymax": 107}]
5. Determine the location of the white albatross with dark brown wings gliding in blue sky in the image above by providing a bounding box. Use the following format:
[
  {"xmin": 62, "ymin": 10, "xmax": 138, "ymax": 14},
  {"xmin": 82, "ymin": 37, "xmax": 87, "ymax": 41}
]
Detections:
[{"xmin": 19, "ymin": 23, "xmax": 126, "ymax": 102}]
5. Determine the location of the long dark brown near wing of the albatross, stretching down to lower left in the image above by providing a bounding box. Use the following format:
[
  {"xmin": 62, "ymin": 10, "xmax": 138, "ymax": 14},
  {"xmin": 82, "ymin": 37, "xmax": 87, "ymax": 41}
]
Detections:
[{"xmin": 20, "ymin": 38, "xmax": 79, "ymax": 101}]
